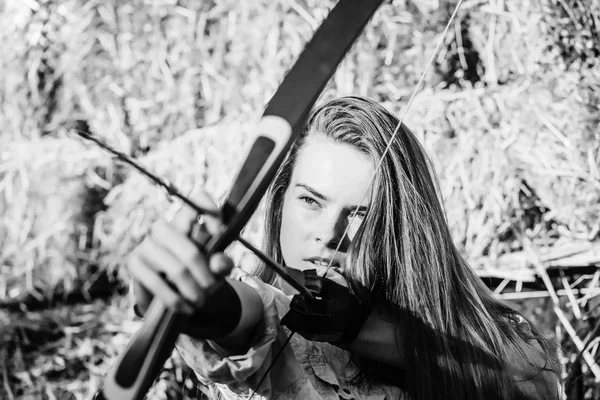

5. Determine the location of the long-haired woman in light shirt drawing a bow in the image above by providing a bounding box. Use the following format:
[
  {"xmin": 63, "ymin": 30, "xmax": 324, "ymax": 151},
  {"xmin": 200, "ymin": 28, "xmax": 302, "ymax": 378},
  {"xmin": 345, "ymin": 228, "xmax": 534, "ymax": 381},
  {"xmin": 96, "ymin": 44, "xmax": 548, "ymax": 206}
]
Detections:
[{"xmin": 129, "ymin": 97, "xmax": 559, "ymax": 399}]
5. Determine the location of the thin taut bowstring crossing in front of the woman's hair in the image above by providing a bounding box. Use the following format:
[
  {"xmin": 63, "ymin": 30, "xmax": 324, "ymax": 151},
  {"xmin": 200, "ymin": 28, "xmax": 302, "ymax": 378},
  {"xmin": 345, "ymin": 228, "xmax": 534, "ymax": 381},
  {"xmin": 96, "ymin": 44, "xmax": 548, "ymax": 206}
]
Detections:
[{"xmin": 321, "ymin": 0, "xmax": 463, "ymax": 279}]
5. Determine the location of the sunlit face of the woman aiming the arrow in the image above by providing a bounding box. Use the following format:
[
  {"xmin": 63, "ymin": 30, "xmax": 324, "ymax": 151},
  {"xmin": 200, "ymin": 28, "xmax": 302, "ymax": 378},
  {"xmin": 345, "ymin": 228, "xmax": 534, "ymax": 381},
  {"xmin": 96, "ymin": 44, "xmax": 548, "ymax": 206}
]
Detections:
[{"xmin": 280, "ymin": 136, "xmax": 373, "ymax": 270}]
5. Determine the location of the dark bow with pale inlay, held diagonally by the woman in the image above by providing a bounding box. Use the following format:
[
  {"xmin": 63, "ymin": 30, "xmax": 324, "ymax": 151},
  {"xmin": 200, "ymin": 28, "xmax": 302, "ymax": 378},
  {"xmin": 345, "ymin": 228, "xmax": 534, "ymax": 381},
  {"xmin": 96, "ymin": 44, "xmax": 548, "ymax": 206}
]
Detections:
[{"xmin": 96, "ymin": 0, "xmax": 383, "ymax": 400}]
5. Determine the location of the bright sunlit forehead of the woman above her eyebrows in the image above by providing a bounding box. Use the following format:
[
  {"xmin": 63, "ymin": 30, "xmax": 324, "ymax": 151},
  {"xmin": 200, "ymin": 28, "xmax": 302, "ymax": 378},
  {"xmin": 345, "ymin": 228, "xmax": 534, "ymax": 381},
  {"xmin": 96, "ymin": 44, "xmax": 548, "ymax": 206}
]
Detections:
[{"xmin": 291, "ymin": 135, "xmax": 374, "ymax": 204}]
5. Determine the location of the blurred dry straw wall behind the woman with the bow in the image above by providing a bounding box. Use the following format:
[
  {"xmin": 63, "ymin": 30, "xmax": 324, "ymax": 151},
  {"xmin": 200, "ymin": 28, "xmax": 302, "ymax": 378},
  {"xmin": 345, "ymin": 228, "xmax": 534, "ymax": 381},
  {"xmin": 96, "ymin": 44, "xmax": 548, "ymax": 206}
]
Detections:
[{"xmin": 0, "ymin": 0, "xmax": 600, "ymax": 400}]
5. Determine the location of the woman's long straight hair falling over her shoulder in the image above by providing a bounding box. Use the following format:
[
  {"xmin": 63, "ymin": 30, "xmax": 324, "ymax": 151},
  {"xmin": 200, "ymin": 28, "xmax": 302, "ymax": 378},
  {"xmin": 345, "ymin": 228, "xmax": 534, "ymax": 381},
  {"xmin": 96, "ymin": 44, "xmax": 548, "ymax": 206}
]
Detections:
[{"xmin": 259, "ymin": 97, "xmax": 556, "ymax": 399}]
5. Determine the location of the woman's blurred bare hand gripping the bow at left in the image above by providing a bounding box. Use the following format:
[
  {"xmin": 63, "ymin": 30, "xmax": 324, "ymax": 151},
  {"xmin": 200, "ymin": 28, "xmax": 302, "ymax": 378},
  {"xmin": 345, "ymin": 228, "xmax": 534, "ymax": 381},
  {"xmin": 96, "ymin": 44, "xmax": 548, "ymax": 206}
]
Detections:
[{"xmin": 127, "ymin": 193, "xmax": 233, "ymax": 314}]
